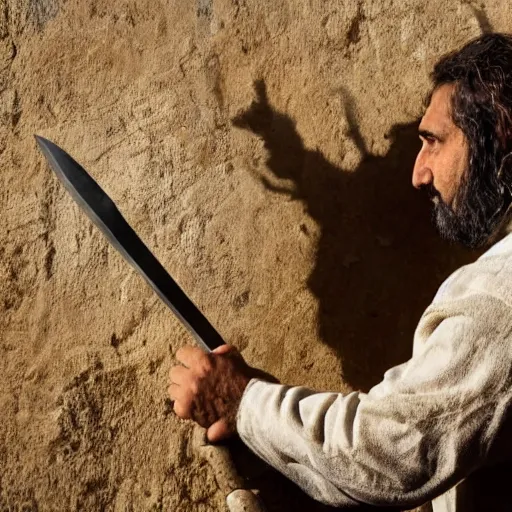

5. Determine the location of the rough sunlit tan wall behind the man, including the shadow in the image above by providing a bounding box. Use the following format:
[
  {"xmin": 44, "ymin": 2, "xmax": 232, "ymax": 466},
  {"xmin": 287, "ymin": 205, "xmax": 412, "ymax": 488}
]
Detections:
[{"xmin": 0, "ymin": 0, "xmax": 512, "ymax": 511}]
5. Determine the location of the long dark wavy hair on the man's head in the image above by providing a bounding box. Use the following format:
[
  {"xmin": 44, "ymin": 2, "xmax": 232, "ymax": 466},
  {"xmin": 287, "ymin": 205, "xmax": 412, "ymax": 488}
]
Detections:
[{"xmin": 432, "ymin": 34, "xmax": 512, "ymax": 247}]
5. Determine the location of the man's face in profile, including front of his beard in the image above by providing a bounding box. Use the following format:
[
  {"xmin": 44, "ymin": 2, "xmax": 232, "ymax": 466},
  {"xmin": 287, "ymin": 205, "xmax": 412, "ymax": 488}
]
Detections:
[{"xmin": 412, "ymin": 84, "xmax": 469, "ymax": 242}]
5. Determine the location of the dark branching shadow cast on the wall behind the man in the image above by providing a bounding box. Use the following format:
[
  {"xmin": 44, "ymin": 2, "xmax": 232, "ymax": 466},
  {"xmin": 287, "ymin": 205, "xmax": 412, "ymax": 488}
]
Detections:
[{"xmin": 232, "ymin": 81, "xmax": 475, "ymax": 391}]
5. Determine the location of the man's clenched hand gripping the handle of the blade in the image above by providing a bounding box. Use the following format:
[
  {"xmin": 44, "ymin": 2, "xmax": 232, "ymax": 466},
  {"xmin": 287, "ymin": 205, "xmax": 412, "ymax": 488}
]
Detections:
[{"xmin": 169, "ymin": 345, "xmax": 272, "ymax": 442}]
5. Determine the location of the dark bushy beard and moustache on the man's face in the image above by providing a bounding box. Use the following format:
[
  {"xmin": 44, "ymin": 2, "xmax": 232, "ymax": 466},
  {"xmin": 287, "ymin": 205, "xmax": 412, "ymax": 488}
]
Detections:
[{"xmin": 421, "ymin": 178, "xmax": 508, "ymax": 249}]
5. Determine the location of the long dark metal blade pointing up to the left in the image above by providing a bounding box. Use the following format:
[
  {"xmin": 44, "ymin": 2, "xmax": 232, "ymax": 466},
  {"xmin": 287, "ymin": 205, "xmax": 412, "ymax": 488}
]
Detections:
[{"xmin": 35, "ymin": 135, "xmax": 224, "ymax": 352}]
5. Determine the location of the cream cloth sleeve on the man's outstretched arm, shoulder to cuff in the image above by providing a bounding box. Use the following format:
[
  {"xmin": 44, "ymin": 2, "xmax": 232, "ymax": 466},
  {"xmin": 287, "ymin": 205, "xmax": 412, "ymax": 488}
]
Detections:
[{"xmin": 237, "ymin": 294, "xmax": 512, "ymax": 507}]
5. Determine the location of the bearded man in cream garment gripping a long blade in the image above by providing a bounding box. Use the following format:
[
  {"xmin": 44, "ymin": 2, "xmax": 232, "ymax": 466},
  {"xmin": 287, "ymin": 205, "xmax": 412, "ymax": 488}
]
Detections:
[{"xmin": 169, "ymin": 34, "xmax": 512, "ymax": 512}]
